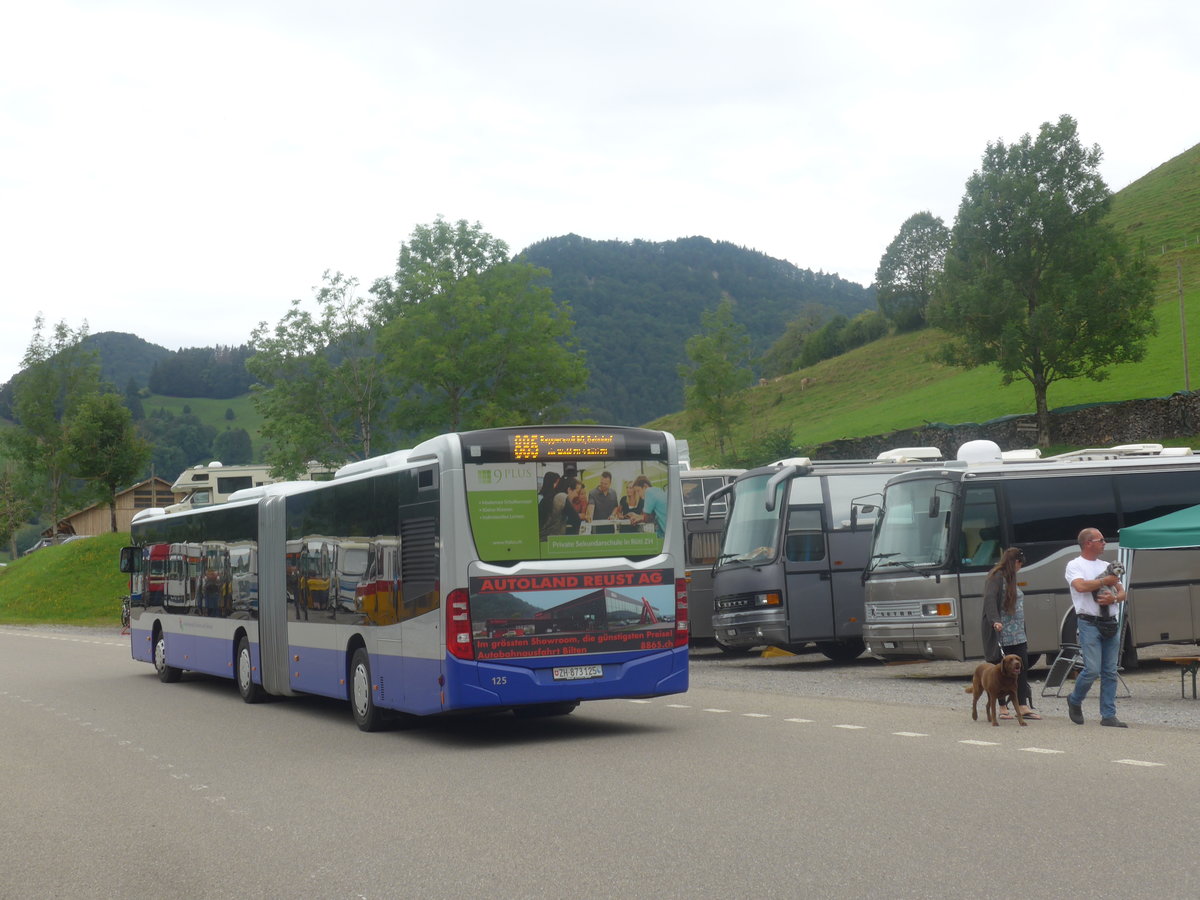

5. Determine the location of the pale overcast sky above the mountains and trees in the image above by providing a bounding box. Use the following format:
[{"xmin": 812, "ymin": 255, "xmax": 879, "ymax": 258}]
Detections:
[{"xmin": 0, "ymin": 0, "xmax": 1200, "ymax": 386}]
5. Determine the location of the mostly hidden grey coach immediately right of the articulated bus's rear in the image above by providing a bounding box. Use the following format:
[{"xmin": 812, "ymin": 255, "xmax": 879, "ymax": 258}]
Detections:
[{"xmin": 679, "ymin": 469, "xmax": 745, "ymax": 644}]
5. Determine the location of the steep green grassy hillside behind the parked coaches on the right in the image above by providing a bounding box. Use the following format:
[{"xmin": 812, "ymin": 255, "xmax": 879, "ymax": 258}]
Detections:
[{"xmin": 654, "ymin": 145, "xmax": 1200, "ymax": 464}]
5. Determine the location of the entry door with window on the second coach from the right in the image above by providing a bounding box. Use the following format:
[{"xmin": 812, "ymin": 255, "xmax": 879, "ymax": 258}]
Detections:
[{"xmin": 782, "ymin": 505, "xmax": 836, "ymax": 644}]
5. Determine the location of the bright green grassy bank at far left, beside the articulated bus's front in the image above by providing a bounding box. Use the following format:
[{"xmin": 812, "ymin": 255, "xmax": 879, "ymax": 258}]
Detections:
[{"xmin": 0, "ymin": 533, "xmax": 130, "ymax": 628}]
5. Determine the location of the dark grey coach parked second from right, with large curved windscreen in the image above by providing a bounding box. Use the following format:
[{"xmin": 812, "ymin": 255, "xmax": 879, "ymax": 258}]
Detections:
[{"xmin": 692, "ymin": 448, "xmax": 941, "ymax": 660}]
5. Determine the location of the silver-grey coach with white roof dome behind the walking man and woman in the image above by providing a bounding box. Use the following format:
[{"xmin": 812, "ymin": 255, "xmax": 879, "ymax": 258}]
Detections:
[{"xmin": 864, "ymin": 442, "xmax": 1200, "ymax": 666}]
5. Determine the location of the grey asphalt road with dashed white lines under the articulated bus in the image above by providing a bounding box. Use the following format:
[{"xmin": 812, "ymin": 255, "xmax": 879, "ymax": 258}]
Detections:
[{"xmin": 0, "ymin": 628, "xmax": 1200, "ymax": 898}]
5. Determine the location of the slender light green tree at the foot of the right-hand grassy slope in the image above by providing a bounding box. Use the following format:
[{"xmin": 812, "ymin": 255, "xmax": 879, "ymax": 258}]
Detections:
[{"xmin": 679, "ymin": 298, "xmax": 751, "ymax": 457}]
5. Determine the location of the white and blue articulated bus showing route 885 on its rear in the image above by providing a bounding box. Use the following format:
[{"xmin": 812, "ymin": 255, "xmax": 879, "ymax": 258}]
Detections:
[{"xmin": 121, "ymin": 426, "xmax": 688, "ymax": 731}]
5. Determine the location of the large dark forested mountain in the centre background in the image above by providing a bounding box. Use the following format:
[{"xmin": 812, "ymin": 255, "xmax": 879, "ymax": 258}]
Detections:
[{"xmin": 521, "ymin": 234, "xmax": 875, "ymax": 425}]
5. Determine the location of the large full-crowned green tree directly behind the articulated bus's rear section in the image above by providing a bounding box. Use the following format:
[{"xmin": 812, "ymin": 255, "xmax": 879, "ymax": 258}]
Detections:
[{"xmin": 377, "ymin": 220, "xmax": 587, "ymax": 432}]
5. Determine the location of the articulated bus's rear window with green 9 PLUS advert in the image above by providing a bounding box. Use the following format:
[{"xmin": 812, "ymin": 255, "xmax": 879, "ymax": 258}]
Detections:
[{"xmin": 463, "ymin": 458, "xmax": 668, "ymax": 563}]
